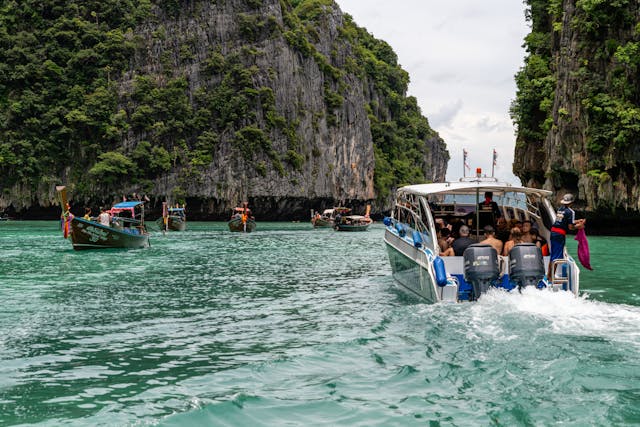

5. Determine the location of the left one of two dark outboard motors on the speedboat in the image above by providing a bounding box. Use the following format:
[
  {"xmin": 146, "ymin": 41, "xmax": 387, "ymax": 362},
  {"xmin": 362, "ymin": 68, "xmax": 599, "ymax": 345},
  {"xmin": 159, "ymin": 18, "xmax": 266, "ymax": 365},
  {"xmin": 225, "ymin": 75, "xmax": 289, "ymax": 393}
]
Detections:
[{"xmin": 462, "ymin": 243, "xmax": 500, "ymax": 300}]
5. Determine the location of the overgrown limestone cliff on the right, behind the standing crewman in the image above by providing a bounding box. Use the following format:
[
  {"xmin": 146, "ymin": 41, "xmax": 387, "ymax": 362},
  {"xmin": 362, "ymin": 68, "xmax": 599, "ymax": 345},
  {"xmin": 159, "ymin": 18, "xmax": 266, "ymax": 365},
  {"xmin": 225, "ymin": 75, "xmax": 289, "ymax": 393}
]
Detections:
[{"xmin": 512, "ymin": 0, "xmax": 640, "ymax": 224}]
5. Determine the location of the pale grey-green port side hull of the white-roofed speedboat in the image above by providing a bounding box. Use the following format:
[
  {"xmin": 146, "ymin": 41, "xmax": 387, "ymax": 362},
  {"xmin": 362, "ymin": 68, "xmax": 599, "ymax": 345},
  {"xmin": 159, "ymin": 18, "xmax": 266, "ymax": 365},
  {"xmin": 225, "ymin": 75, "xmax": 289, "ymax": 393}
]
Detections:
[{"xmin": 384, "ymin": 230, "xmax": 442, "ymax": 303}]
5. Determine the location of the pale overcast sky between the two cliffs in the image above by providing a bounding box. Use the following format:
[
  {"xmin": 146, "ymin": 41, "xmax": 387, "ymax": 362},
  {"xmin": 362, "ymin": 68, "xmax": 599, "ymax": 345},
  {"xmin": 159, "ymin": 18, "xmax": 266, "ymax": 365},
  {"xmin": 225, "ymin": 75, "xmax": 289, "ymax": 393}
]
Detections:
[{"xmin": 336, "ymin": 0, "xmax": 529, "ymax": 184}]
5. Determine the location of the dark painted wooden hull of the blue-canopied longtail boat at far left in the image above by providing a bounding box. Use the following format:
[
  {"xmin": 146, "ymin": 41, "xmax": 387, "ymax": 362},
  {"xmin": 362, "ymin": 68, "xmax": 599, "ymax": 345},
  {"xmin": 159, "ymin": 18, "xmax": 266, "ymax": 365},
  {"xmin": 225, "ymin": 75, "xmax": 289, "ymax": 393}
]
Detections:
[{"xmin": 70, "ymin": 218, "xmax": 149, "ymax": 251}]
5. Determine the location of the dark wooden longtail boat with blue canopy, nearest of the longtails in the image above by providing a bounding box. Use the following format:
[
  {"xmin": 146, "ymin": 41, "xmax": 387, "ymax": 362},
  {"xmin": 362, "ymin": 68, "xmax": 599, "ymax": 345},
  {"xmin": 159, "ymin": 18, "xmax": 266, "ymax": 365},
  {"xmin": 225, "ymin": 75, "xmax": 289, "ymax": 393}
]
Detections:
[{"xmin": 56, "ymin": 186, "xmax": 149, "ymax": 251}]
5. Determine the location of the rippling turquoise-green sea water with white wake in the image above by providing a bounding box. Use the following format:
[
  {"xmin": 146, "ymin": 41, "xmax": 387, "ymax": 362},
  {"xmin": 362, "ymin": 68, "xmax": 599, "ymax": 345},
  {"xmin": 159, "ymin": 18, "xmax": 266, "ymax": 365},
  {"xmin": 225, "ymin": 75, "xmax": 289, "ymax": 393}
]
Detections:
[{"xmin": 0, "ymin": 221, "xmax": 640, "ymax": 426}]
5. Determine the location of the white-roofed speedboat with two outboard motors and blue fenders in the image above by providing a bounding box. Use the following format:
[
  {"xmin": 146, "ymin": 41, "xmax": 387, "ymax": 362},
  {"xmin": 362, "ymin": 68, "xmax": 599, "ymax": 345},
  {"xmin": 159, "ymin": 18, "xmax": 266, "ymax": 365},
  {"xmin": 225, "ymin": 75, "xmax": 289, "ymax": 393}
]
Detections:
[{"xmin": 384, "ymin": 174, "xmax": 580, "ymax": 303}]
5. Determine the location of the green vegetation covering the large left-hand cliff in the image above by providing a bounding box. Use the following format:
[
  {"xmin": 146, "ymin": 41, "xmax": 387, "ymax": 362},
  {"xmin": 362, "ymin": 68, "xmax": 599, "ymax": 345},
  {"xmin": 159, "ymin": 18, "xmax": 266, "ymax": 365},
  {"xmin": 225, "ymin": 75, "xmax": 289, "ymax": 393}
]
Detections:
[{"xmin": 0, "ymin": 0, "xmax": 437, "ymax": 205}]
